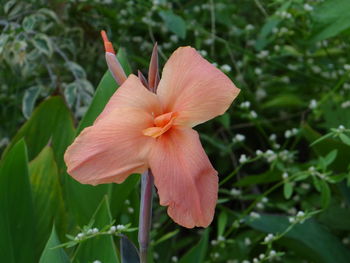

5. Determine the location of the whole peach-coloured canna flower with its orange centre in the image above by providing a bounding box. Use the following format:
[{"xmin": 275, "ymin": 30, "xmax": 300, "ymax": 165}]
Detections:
[{"xmin": 64, "ymin": 35, "xmax": 240, "ymax": 228}]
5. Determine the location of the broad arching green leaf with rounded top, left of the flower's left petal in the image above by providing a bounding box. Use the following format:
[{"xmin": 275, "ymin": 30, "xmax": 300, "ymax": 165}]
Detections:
[{"xmin": 4, "ymin": 96, "xmax": 75, "ymax": 171}]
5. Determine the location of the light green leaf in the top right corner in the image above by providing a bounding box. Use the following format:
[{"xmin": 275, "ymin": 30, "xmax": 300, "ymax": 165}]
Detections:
[{"xmin": 312, "ymin": 0, "xmax": 350, "ymax": 42}]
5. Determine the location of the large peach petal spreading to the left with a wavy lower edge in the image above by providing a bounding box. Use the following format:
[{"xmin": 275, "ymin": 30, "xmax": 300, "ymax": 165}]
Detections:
[{"xmin": 64, "ymin": 108, "xmax": 154, "ymax": 185}]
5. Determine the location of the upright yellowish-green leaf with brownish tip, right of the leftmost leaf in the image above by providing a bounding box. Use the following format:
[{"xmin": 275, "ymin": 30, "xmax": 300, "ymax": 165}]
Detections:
[{"xmin": 29, "ymin": 146, "xmax": 64, "ymax": 256}]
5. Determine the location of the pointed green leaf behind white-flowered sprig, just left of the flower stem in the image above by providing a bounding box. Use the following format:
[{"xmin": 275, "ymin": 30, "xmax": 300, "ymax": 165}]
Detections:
[{"xmin": 73, "ymin": 196, "xmax": 119, "ymax": 263}]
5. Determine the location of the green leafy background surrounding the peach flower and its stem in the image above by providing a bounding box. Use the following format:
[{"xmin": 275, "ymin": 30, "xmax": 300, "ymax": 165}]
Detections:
[{"xmin": 0, "ymin": 0, "xmax": 350, "ymax": 263}]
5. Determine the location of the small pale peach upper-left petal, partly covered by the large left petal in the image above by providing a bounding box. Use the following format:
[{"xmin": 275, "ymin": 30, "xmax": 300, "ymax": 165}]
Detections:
[{"xmin": 95, "ymin": 74, "xmax": 161, "ymax": 123}]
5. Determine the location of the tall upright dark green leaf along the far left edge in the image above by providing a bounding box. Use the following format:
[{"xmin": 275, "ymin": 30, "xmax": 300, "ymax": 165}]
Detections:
[{"xmin": 0, "ymin": 140, "xmax": 37, "ymax": 263}]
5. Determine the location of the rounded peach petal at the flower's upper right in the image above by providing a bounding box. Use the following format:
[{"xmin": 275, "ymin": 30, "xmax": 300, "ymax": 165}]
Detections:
[{"xmin": 157, "ymin": 47, "xmax": 240, "ymax": 127}]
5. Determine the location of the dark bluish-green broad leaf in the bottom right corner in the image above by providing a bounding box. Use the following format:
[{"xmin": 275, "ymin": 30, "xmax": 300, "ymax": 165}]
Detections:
[{"xmin": 247, "ymin": 214, "xmax": 350, "ymax": 263}]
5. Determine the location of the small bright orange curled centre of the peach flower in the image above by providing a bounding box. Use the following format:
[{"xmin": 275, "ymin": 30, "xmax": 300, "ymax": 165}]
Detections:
[{"xmin": 142, "ymin": 112, "xmax": 178, "ymax": 138}]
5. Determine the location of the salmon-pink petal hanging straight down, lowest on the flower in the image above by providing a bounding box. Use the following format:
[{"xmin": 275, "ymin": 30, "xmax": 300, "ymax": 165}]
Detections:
[{"xmin": 149, "ymin": 128, "xmax": 218, "ymax": 228}]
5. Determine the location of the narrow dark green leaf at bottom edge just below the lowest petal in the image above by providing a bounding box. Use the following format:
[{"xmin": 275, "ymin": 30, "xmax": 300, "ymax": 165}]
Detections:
[{"xmin": 179, "ymin": 228, "xmax": 209, "ymax": 263}]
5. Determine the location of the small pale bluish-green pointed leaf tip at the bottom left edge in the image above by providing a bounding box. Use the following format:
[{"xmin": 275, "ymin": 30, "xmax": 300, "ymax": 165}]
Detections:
[{"xmin": 39, "ymin": 226, "xmax": 70, "ymax": 263}]
